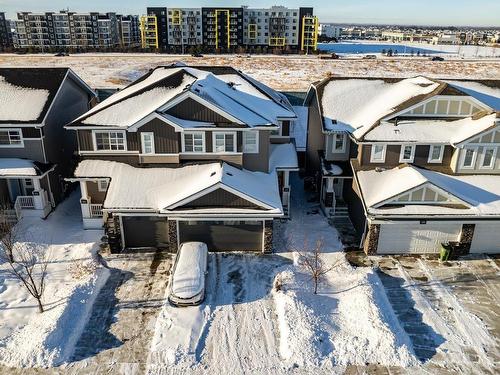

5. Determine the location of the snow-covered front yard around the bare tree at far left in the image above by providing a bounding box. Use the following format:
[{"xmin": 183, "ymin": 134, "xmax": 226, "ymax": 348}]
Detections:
[{"xmin": 0, "ymin": 193, "xmax": 109, "ymax": 367}]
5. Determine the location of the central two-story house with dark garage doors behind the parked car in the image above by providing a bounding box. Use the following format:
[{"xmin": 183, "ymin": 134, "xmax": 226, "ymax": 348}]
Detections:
[{"xmin": 66, "ymin": 65, "xmax": 298, "ymax": 251}]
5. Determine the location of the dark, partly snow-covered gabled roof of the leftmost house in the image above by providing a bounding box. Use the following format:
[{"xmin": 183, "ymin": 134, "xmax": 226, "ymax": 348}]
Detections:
[{"xmin": 0, "ymin": 68, "xmax": 95, "ymax": 124}]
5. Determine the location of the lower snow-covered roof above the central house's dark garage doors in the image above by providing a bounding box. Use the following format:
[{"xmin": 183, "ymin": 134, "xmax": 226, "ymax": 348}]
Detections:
[{"xmin": 75, "ymin": 160, "xmax": 282, "ymax": 215}]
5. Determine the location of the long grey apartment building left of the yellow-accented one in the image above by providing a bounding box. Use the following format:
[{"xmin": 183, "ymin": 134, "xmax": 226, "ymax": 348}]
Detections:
[{"xmin": 15, "ymin": 11, "xmax": 121, "ymax": 50}]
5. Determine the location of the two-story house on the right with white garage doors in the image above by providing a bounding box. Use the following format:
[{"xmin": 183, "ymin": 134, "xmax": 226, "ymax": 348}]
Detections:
[{"xmin": 306, "ymin": 77, "xmax": 500, "ymax": 254}]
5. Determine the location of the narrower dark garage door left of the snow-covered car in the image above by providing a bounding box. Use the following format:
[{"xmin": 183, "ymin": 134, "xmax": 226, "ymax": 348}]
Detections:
[{"xmin": 122, "ymin": 216, "xmax": 168, "ymax": 248}]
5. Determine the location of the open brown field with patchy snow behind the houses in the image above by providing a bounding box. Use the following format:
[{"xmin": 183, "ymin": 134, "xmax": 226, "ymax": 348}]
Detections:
[{"xmin": 0, "ymin": 53, "xmax": 500, "ymax": 91}]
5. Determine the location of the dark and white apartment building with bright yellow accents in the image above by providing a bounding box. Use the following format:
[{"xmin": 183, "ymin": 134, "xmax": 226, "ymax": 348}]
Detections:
[{"xmin": 141, "ymin": 6, "xmax": 319, "ymax": 52}]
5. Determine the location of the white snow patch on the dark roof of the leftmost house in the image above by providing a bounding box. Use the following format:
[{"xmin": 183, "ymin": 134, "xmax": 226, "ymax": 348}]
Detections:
[{"xmin": 0, "ymin": 76, "xmax": 49, "ymax": 121}]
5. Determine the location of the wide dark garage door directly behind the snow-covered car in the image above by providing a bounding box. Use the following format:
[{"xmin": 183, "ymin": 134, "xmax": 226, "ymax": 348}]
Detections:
[{"xmin": 179, "ymin": 221, "xmax": 263, "ymax": 251}]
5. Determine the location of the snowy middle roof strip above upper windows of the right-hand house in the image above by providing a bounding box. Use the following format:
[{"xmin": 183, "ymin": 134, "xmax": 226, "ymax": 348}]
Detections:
[{"xmin": 364, "ymin": 113, "xmax": 497, "ymax": 144}]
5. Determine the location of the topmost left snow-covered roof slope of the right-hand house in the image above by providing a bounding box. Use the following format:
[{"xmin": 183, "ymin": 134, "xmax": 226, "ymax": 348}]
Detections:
[{"xmin": 320, "ymin": 76, "xmax": 441, "ymax": 138}]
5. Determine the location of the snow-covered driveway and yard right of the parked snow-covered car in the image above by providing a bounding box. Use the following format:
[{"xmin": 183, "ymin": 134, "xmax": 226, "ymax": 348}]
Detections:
[{"xmin": 148, "ymin": 175, "xmax": 417, "ymax": 374}]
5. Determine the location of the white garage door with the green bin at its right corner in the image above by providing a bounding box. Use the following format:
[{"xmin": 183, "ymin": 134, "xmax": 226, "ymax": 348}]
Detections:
[{"xmin": 377, "ymin": 221, "xmax": 462, "ymax": 254}]
